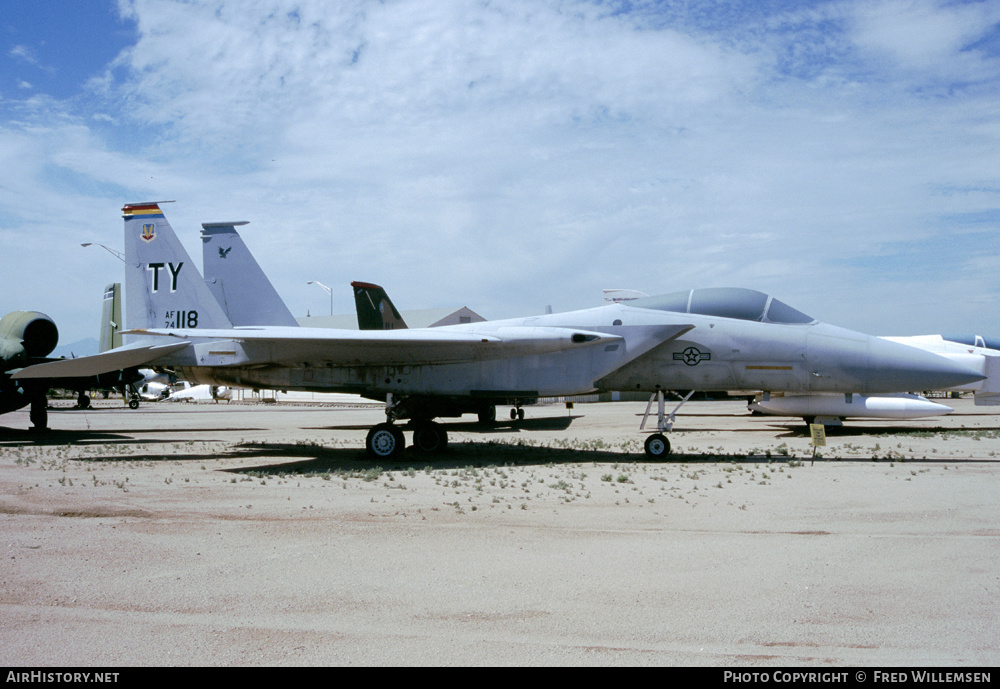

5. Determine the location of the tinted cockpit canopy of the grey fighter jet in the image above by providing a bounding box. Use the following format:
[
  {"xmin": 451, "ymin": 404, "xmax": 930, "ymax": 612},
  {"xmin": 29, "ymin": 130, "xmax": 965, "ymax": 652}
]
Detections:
[{"xmin": 628, "ymin": 287, "xmax": 816, "ymax": 325}]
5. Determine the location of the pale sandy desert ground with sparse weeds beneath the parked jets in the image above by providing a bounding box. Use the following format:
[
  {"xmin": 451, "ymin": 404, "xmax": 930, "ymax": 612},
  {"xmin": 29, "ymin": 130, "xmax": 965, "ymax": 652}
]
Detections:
[{"xmin": 0, "ymin": 400, "xmax": 1000, "ymax": 667}]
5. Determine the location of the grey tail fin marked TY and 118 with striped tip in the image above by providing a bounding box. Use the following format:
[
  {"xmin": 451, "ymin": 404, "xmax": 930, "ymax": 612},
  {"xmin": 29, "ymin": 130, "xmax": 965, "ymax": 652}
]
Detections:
[{"xmin": 122, "ymin": 203, "xmax": 232, "ymax": 339}]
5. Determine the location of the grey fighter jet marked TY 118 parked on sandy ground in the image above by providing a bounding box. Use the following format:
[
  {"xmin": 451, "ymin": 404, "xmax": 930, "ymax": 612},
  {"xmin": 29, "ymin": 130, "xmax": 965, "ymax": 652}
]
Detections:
[{"xmin": 20, "ymin": 203, "xmax": 982, "ymax": 457}]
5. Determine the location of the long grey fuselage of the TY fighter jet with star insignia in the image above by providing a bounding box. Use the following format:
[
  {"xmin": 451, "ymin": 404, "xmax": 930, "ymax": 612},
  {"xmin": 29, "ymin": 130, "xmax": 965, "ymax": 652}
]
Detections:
[{"xmin": 150, "ymin": 304, "xmax": 974, "ymax": 397}]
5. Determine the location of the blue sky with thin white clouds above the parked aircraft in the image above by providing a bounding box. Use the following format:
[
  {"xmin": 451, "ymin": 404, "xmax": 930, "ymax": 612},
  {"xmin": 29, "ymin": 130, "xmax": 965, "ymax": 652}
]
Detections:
[{"xmin": 0, "ymin": 0, "xmax": 1000, "ymax": 344}]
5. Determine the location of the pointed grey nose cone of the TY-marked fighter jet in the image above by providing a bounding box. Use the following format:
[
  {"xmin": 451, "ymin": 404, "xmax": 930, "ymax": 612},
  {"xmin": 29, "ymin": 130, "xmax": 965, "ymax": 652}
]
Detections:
[{"xmin": 866, "ymin": 337, "xmax": 985, "ymax": 392}]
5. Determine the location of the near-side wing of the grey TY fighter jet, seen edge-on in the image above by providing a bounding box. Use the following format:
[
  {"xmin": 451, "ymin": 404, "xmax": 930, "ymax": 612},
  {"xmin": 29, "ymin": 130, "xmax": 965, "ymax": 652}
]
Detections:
[{"xmin": 125, "ymin": 326, "xmax": 623, "ymax": 363}]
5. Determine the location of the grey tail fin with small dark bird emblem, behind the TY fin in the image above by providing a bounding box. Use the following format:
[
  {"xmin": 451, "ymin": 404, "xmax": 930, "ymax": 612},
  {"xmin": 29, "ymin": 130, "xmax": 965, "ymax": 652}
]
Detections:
[{"xmin": 201, "ymin": 222, "xmax": 298, "ymax": 326}]
